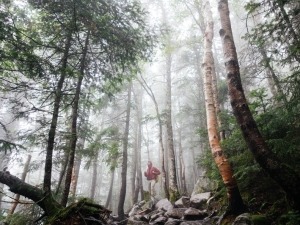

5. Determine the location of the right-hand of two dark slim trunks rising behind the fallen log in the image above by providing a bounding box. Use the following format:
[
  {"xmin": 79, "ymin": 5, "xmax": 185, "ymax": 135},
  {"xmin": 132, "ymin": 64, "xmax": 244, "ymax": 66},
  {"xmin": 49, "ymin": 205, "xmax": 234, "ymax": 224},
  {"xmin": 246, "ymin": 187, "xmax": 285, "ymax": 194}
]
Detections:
[{"xmin": 61, "ymin": 31, "xmax": 90, "ymax": 206}]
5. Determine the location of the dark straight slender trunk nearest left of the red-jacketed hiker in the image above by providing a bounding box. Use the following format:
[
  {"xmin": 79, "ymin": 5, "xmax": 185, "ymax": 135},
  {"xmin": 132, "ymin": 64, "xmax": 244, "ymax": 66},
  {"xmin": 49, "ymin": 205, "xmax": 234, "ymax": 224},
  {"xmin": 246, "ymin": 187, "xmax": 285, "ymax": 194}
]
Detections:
[{"xmin": 118, "ymin": 82, "xmax": 132, "ymax": 221}]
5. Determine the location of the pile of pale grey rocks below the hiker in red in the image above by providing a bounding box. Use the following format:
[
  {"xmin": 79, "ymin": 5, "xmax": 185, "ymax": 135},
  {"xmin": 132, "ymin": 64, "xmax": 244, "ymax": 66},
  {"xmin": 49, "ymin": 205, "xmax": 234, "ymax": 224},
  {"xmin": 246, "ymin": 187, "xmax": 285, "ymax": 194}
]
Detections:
[{"xmin": 123, "ymin": 192, "xmax": 218, "ymax": 225}]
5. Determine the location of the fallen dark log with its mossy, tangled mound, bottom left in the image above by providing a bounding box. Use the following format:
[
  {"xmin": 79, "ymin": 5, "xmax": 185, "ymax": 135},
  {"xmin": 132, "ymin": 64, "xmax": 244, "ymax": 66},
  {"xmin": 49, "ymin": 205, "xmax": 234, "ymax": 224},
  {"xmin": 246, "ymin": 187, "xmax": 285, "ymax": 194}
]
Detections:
[{"xmin": 0, "ymin": 171, "xmax": 111, "ymax": 225}]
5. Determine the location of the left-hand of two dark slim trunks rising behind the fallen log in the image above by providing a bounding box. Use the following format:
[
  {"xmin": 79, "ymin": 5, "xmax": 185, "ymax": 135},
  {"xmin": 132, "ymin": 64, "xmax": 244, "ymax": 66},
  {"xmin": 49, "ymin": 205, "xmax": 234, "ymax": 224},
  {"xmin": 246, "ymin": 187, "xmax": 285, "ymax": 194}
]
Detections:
[{"xmin": 43, "ymin": 31, "xmax": 72, "ymax": 193}]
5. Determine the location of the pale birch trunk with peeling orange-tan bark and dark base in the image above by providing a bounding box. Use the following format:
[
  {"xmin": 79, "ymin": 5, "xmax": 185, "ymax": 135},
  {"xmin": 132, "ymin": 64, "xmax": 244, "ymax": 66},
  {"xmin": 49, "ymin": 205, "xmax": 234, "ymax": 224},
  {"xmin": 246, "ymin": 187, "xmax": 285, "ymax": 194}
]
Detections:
[{"xmin": 202, "ymin": 2, "xmax": 245, "ymax": 214}]
